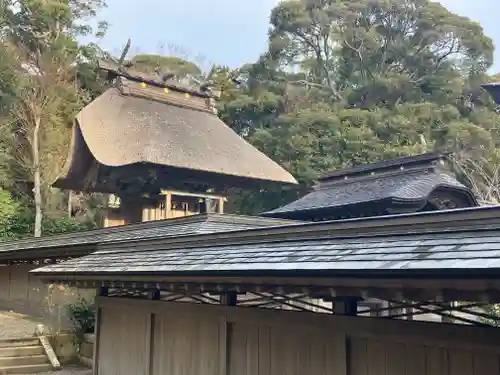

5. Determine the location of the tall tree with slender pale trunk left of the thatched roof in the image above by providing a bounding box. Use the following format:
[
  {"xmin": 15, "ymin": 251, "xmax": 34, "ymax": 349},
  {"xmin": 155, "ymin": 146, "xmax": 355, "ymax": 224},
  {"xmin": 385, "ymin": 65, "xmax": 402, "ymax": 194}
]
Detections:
[{"xmin": 0, "ymin": 0, "xmax": 105, "ymax": 236}]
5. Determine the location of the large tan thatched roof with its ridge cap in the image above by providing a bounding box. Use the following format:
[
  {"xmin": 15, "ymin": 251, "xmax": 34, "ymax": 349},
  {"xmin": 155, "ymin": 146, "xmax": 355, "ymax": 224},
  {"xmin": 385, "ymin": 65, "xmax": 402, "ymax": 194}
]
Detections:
[{"xmin": 55, "ymin": 67, "xmax": 296, "ymax": 190}]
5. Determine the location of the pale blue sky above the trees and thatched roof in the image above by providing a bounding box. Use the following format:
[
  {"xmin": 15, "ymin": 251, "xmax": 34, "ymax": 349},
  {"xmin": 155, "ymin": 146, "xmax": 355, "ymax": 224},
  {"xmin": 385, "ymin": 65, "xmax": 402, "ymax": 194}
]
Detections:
[{"xmin": 94, "ymin": 0, "xmax": 500, "ymax": 73}]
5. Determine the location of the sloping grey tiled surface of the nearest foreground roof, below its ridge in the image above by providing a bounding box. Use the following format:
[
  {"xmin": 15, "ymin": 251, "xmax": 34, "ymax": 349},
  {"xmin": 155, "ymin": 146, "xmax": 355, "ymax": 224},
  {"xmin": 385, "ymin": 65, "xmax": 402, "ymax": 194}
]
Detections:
[{"xmin": 34, "ymin": 229, "xmax": 500, "ymax": 274}]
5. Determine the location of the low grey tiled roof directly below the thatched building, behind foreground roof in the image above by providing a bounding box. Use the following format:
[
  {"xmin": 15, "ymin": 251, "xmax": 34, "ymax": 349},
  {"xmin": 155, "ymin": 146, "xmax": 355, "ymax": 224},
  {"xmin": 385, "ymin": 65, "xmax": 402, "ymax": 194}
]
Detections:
[{"xmin": 0, "ymin": 214, "xmax": 297, "ymax": 256}]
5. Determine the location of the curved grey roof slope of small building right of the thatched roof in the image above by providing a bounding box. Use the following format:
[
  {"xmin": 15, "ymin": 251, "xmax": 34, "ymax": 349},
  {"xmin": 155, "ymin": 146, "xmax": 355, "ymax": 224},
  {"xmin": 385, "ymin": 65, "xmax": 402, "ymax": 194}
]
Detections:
[{"xmin": 264, "ymin": 170, "xmax": 469, "ymax": 217}]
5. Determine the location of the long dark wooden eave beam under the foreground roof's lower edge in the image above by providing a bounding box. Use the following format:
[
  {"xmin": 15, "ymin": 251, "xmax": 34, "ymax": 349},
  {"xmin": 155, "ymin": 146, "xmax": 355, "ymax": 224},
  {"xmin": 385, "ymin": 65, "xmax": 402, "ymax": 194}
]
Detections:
[{"xmin": 47, "ymin": 275, "xmax": 500, "ymax": 304}]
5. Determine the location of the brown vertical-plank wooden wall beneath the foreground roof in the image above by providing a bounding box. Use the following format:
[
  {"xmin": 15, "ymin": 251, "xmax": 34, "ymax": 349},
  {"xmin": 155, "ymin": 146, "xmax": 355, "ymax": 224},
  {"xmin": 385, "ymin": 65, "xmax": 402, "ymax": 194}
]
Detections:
[{"xmin": 97, "ymin": 298, "xmax": 500, "ymax": 375}]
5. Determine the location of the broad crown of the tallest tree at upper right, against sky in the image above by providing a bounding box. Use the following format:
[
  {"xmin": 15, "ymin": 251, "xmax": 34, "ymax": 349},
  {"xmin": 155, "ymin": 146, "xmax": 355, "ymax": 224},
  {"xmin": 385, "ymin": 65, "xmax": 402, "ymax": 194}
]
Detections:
[{"xmin": 269, "ymin": 0, "xmax": 493, "ymax": 100}]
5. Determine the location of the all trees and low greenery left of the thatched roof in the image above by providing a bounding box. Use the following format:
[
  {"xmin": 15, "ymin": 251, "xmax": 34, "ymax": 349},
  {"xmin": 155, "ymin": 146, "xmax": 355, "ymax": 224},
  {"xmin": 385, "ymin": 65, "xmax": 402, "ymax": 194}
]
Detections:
[{"xmin": 0, "ymin": 0, "xmax": 106, "ymax": 238}]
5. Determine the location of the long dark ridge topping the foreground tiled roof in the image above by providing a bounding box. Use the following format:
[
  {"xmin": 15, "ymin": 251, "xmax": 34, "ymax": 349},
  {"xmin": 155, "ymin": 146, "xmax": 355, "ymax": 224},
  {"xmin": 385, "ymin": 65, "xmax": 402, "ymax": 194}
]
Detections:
[{"xmin": 45, "ymin": 206, "xmax": 500, "ymax": 260}]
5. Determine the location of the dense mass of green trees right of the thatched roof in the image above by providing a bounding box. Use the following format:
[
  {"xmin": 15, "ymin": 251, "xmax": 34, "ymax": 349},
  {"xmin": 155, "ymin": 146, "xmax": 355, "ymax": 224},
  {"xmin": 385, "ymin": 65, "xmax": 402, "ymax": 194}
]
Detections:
[{"xmin": 220, "ymin": 0, "xmax": 500, "ymax": 213}]
